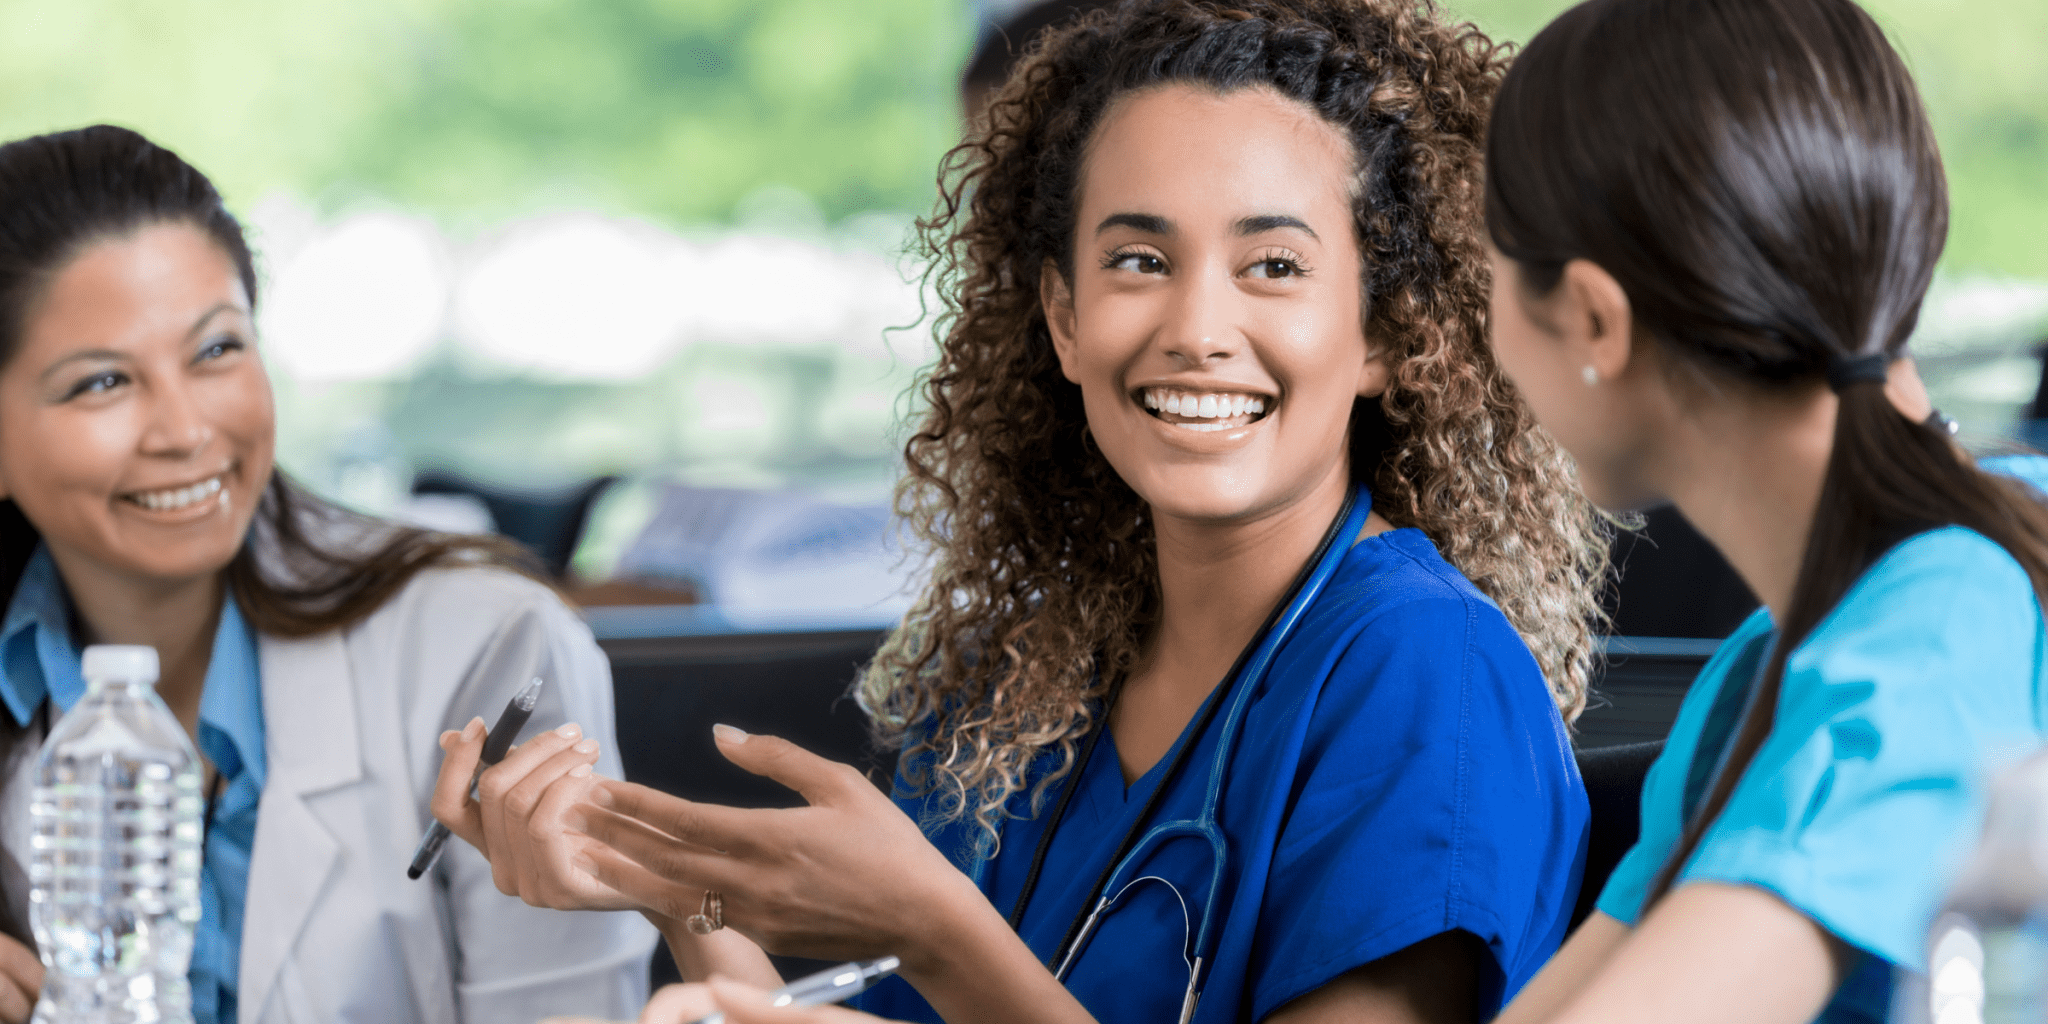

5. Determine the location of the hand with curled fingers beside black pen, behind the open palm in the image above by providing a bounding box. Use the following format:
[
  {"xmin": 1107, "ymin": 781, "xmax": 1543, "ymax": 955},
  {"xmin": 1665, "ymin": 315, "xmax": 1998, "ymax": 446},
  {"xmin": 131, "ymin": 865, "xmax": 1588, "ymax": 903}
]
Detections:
[{"xmin": 432, "ymin": 719, "xmax": 641, "ymax": 909}]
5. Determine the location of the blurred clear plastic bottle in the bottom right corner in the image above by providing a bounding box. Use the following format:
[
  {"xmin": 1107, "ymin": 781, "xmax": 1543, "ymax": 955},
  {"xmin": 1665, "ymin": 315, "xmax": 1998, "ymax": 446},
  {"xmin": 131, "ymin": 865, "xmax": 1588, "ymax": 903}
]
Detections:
[{"xmin": 1894, "ymin": 752, "xmax": 2048, "ymax": 1024}]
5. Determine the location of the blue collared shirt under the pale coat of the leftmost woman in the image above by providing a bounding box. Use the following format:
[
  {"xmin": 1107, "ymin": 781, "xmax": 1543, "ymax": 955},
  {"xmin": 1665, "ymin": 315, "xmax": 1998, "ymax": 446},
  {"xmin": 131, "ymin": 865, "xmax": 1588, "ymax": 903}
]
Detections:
[{"xmin": 0, "ymin": 547, "xmax": 264, "ymax": 1024}]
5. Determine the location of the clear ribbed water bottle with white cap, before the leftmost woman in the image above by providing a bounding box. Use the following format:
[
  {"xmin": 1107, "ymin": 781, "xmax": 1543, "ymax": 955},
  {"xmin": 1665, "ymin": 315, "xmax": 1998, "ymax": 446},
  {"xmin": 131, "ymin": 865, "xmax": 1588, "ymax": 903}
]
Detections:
[{"xmin": 29, "ymin": 647, "xmax": 201, "ymax": 1024}]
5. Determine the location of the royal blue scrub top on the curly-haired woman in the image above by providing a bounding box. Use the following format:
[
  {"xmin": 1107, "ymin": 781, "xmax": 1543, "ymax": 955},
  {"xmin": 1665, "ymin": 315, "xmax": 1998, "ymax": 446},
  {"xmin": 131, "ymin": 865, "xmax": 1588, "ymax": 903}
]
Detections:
[{"xmin": 858, "ymin": 528, "xmax": 1587, "ymax": 1024}]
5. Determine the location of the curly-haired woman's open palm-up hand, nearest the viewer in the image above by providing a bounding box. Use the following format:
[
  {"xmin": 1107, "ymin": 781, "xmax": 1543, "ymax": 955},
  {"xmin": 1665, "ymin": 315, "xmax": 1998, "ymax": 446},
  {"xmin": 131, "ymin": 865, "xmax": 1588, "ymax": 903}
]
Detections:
[{"xmin": 580, "ymin": 725, "xmax": 987, "ymax": 973}]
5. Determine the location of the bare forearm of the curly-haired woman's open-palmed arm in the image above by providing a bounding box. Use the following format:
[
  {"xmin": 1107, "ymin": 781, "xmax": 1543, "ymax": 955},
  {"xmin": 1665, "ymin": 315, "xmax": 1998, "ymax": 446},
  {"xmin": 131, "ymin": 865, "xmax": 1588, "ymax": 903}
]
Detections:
[{"xmin": 901, "ymin": 889, "xmax": 1096, "ymax": 1024}]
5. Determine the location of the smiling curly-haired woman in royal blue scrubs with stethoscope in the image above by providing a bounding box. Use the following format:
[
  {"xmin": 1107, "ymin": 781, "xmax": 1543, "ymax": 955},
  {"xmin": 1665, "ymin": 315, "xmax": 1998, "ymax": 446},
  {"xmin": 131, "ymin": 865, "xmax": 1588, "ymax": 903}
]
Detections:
[{"xmin": 436, "ymin": 0, "xmax": 1604, "ymax": 1022}]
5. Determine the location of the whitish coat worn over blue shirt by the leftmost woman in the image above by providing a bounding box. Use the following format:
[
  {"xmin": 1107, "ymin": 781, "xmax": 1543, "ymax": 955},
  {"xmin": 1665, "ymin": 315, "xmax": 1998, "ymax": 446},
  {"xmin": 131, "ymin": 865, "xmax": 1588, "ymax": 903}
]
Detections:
[{"xmin": 240, "ymin": 567, "xmax": 655, "ymax": 1024}]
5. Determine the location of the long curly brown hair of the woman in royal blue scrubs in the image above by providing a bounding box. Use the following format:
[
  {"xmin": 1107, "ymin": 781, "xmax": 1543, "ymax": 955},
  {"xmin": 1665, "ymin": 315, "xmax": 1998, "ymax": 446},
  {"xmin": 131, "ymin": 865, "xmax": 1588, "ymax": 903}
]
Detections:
[{"xmin": 860, "ymin": 0, "xmax": 1608, "ymax": 840}]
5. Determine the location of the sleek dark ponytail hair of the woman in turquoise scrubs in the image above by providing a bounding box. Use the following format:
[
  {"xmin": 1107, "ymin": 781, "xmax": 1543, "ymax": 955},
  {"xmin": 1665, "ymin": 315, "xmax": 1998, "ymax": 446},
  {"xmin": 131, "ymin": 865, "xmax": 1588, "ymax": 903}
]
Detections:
[{"xmin": 1487, "ymin": 0, "xmax": 2048, "ymax": 905}]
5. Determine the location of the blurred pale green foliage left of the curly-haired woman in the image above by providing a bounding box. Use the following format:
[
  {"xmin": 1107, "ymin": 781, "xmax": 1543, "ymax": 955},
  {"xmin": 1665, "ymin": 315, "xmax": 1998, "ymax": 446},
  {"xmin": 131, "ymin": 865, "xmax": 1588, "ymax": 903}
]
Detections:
[{"xmin": 0, "ymin": 0, "xmax": 971, "ymax": 225}]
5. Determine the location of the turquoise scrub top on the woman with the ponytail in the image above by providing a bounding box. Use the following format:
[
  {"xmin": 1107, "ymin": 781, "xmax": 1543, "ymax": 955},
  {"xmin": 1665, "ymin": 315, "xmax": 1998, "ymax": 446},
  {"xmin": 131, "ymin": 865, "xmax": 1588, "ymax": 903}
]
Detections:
[{"xmin": 1599, "ymin": 524, "xmax": 2048, "ymax": 1024}]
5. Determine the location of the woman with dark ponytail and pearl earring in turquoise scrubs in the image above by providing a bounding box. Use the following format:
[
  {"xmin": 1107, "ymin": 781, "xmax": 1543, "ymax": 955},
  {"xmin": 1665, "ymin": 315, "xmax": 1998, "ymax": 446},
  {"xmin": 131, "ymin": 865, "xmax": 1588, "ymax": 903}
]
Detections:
[{"xmin": 1487, "ymin": 0, "xmax": 2048, "ymax": 1024}]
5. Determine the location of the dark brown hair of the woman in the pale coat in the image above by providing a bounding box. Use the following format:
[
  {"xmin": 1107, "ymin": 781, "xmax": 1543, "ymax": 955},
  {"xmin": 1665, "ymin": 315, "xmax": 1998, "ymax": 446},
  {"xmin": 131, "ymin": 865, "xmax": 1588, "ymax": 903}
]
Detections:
[{"xmin": 0, "ymin": 125, "xmax": 543, "ymax": 637}]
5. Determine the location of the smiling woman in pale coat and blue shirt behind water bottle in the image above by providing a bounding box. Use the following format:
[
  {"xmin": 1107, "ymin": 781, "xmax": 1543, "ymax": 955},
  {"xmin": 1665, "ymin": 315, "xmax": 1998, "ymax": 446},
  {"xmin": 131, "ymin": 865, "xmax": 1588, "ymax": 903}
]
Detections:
[{"xmin": 0, "ymin": 125, "xmax": 653, "ymax": 1024}]
